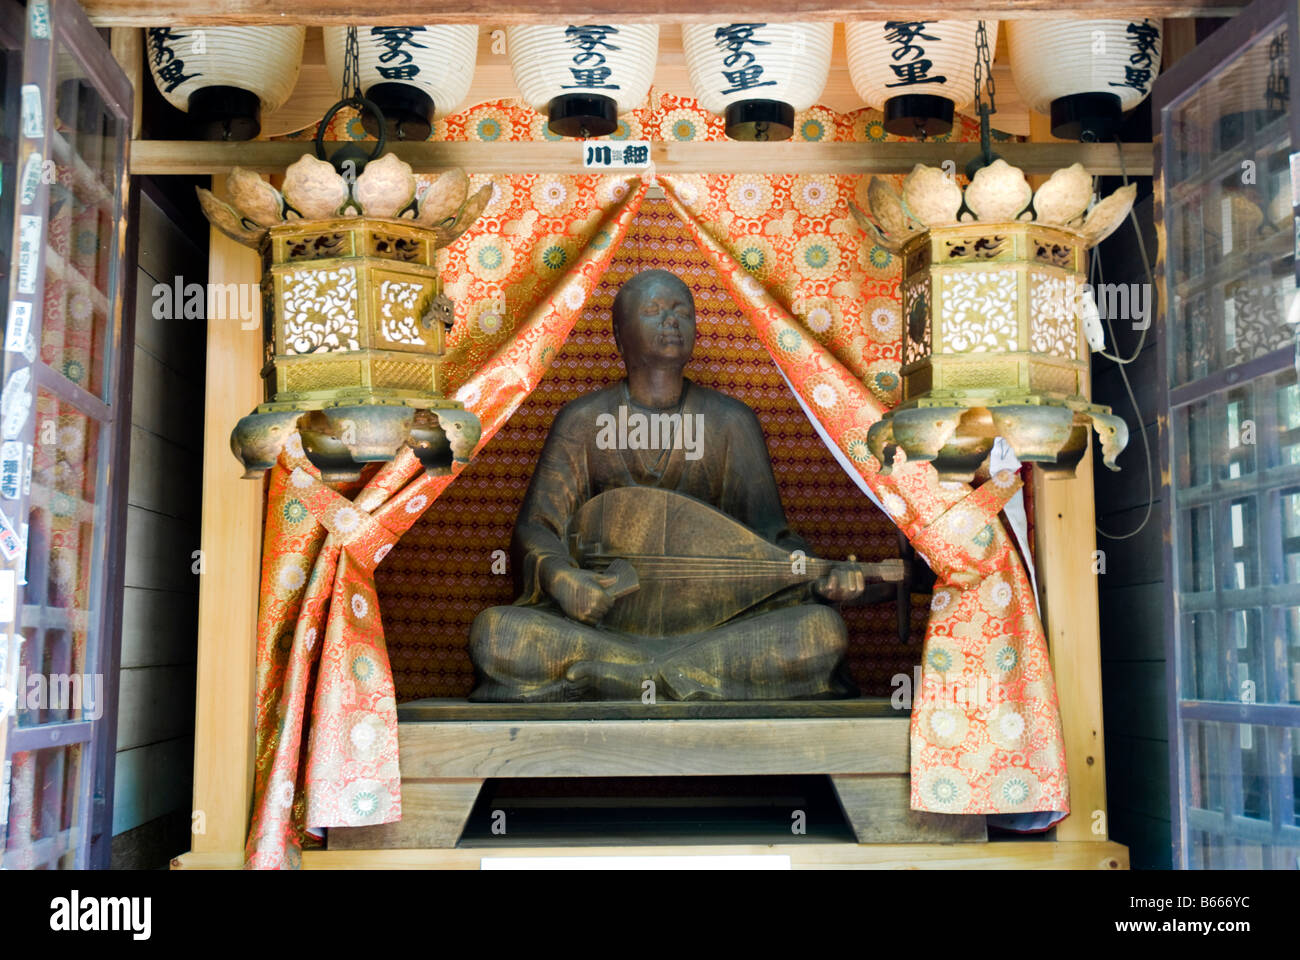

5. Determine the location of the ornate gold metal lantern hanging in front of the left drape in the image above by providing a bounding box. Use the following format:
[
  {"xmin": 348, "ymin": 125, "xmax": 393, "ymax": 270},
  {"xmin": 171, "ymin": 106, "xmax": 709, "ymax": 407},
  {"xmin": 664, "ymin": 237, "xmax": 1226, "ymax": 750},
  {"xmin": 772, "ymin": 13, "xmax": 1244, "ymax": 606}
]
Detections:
[{"xmin": 199, "ymin": 155, "xmax": 491, "ymax": 481}]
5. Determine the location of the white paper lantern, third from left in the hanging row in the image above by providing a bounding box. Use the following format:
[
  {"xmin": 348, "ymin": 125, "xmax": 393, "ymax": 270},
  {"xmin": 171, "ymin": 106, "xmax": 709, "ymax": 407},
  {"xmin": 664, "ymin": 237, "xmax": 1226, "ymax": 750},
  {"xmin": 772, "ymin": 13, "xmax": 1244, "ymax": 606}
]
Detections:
[{"xmin": 506, "ymin": 23, "xmax": 659, "ymax": 137}]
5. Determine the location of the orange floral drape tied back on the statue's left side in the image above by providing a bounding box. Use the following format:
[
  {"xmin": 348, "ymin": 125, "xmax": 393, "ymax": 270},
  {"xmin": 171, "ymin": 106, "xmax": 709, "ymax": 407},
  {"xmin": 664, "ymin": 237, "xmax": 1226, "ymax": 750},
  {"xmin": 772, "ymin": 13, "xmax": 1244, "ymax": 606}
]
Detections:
[{"xmin": 246, "ymin": 176, "xmax": 646, "ymax": 868}]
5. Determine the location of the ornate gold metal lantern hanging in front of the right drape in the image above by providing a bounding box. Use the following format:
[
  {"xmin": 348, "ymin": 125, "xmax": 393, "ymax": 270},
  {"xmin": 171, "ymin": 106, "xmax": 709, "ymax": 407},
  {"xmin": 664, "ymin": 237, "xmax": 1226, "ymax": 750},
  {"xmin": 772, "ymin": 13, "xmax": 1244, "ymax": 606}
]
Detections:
[{"xmin": 854, "ymin": 160, "xmax": 1136, "ymax": 481}]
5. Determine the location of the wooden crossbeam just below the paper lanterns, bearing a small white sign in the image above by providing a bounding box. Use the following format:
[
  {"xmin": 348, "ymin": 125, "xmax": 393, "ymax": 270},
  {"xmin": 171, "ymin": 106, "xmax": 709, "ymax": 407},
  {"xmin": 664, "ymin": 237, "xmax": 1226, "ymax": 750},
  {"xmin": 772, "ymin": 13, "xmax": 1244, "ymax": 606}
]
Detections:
[{"xmin": 131, "ymin": 140, "xmax": 1153, "ymax": 177}]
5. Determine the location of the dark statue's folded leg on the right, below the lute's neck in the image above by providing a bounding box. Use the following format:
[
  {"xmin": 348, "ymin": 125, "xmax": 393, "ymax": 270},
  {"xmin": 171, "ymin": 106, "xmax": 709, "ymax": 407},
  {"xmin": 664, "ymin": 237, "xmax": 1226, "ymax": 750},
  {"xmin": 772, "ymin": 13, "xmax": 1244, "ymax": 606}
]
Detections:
[{"xmin": 659, "ymin": 604, "xmax": 853, "ymax": 700}]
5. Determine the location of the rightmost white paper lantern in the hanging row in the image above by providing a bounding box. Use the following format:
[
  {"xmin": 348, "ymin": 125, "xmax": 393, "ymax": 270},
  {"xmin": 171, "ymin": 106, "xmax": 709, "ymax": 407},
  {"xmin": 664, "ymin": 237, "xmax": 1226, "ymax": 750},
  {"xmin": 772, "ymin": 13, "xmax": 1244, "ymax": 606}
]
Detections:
[{"xmin": 1006, "ymin": 20, "xmax": 1161, "ymax": 140}]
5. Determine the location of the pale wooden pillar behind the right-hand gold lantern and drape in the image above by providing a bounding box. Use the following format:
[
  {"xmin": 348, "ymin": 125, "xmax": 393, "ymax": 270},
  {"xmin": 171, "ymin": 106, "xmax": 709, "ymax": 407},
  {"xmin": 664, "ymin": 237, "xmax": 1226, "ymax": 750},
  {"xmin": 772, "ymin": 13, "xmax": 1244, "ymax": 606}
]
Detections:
[{"xmin": 1030, "ymin": 113, "xmax": 1109, "ymax": 840}]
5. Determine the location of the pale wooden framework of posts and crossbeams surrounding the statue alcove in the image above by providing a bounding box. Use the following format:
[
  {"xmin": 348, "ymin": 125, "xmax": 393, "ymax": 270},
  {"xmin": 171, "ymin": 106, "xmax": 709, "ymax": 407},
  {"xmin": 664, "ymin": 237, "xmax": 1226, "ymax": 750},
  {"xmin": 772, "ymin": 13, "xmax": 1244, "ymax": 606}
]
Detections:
[{"xmin": 134, "ymin": 0, "xmax": 1190, "ymax": 869}]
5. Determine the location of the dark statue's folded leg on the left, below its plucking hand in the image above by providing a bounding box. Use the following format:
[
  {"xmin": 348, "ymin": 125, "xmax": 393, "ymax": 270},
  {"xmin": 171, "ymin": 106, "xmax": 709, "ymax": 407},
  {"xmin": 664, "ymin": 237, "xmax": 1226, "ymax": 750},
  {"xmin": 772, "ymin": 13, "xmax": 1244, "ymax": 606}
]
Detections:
[{"xmin": 469, "ymin": 606, "xmax": 654, "ymax": 702}]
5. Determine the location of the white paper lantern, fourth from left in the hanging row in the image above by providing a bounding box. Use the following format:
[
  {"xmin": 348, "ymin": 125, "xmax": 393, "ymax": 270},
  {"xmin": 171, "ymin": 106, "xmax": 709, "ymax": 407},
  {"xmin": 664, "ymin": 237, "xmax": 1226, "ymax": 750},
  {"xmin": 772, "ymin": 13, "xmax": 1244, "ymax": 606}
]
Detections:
[{"xmin": 681, "ymin": 23, "xmax": 835, "ymax": 140}]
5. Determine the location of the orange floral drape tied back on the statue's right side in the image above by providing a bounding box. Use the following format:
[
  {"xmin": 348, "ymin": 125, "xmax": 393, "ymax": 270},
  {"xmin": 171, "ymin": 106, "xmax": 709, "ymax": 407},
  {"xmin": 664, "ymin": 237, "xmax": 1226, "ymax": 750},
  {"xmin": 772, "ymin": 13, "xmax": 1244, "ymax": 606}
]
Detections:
[{"xmin": 662, "ymin": 176, "xmax": 1069, "ymax": 816}]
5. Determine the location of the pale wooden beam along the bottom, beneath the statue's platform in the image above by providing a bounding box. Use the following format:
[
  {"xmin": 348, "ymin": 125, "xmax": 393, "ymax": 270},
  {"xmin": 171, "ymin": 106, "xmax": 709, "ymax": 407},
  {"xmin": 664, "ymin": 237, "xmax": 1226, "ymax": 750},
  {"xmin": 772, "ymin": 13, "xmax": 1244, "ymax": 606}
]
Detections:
[{"xmin": 172, "ymin": 836, "xmax": 1128, "ymax": 870}]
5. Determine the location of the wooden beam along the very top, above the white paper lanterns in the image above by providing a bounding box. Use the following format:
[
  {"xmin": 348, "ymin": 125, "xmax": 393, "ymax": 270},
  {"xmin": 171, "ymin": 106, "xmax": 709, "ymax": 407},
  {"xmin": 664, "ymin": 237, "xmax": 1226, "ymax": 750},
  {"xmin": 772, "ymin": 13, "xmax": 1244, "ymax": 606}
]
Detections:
[{"xmin": 82, "ymin": 0, "xmax": 1248, "ymax": 27}]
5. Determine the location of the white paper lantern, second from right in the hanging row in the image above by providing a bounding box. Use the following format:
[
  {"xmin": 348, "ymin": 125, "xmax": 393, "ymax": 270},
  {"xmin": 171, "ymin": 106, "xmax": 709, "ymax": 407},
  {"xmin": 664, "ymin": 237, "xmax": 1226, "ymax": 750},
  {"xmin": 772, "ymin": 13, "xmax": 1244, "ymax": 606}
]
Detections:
[{"xmin": 845, "ymin": 20, "xmax": 997, "ymax": 137}]
